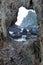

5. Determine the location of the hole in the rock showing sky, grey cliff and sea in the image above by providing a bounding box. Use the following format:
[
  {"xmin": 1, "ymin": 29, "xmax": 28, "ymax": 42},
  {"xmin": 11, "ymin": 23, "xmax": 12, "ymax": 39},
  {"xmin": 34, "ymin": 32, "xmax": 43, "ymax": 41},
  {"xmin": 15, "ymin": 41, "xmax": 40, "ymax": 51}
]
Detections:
[{"xmin": 8, "ymin": 6, "xmax": 39, "ymax": 41}]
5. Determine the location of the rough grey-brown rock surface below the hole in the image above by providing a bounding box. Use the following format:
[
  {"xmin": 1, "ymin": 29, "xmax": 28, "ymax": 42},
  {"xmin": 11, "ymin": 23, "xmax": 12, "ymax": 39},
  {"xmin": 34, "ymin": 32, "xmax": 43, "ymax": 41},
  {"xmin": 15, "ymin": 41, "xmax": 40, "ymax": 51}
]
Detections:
[{"xmin": 0, "ymin": 39, "xmax": 40, "ymax": 65}]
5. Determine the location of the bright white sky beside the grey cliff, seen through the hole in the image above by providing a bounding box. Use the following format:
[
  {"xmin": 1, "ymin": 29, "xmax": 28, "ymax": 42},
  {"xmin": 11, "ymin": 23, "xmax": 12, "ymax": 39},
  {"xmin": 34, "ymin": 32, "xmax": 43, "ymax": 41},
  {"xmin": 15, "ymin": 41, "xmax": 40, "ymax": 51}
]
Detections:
[{"xmin": 15, "ymin": 6, "xmax": 36, "ymax": 26}]
